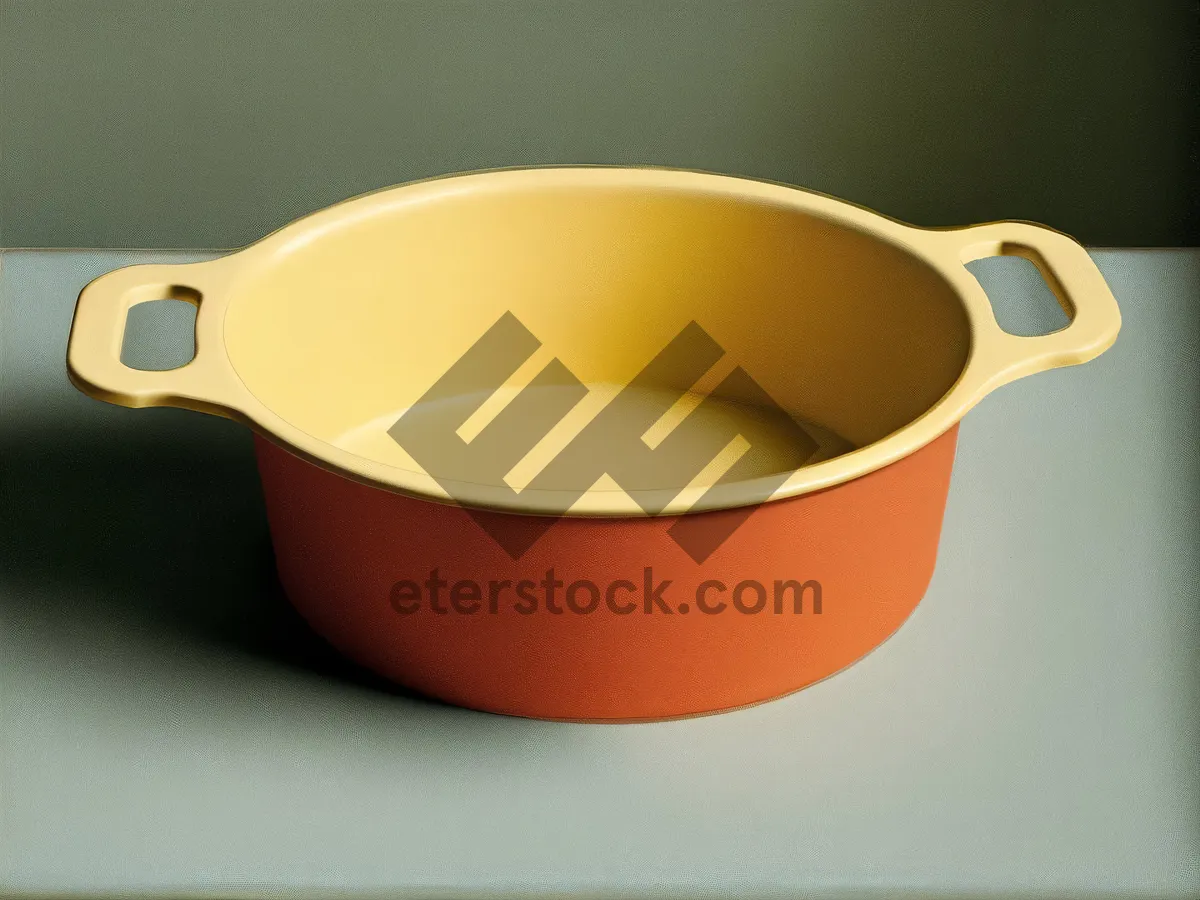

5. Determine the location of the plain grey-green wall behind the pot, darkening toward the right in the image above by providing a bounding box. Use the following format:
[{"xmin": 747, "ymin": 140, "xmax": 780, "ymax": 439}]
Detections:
[{"xmin": 0, "ymin": 0, "xmax": 1200, "ymax": 247}]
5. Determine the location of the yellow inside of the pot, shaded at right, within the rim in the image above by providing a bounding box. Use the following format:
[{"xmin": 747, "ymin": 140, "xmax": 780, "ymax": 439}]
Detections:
[{"xmin": 223, "ymin": 179, "xmax": 971, "ymax": 494}]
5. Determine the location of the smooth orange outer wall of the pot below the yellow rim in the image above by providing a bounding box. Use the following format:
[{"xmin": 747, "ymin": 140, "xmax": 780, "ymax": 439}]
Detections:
[{"xmin": 256, "ymin": 426, "xmax": 958, "ymax": 721}]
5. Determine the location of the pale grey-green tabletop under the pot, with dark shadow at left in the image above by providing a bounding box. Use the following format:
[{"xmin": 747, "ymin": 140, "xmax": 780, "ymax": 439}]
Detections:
[{"xmin": 0, "ymin": 251, "xmax": 1200, "ymax": 898}]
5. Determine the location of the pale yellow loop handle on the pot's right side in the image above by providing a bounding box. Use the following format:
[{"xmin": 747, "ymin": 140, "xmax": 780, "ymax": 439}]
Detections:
[{"xmin": 946, "ymin": 221, "xmax": 1121, "ymax": 386}]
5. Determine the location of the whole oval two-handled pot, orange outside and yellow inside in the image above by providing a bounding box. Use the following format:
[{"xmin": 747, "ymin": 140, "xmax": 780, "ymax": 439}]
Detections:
[{"xmin": 67, "ymin": 167, "xmax": 1120, "ymax": 721}]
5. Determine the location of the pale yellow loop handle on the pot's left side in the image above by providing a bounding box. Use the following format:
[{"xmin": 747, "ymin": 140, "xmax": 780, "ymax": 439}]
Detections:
[{"xmin": 67, "ymin": 259, "xmax": 247, "ymax": 419}]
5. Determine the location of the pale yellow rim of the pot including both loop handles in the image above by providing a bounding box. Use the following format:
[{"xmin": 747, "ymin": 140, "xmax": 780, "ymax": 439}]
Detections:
[{"xmin": 67, "ymin": 166, "xmax": 1121, "ymax": 518}]
